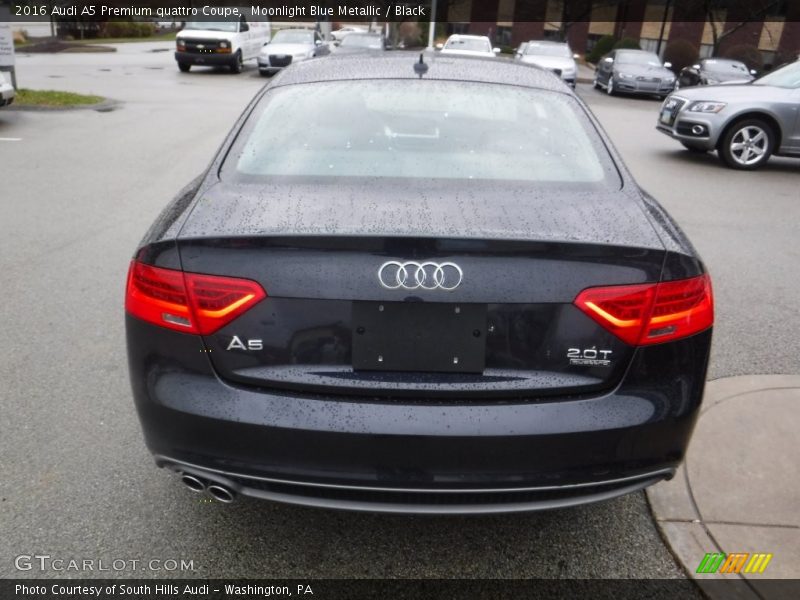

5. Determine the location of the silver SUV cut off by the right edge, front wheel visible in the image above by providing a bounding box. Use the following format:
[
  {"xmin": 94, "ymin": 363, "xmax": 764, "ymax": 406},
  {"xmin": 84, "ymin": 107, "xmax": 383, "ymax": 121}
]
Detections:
[{"xmin": 657, "ymin": 61, "xmax": 800, "ymax": 170}]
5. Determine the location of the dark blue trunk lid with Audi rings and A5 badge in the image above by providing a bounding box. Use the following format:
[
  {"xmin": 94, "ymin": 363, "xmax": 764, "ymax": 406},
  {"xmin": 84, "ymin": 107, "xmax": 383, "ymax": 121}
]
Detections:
[{"xmin": 179, "ymin": 183, "xmax": 665, "ymax": 400}]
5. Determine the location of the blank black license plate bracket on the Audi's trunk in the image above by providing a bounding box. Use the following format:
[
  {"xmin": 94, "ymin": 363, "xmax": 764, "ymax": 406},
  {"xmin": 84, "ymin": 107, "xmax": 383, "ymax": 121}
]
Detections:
[{"xmin": 352, "ymin": 301, "xmax": 487, "ymax": 373}]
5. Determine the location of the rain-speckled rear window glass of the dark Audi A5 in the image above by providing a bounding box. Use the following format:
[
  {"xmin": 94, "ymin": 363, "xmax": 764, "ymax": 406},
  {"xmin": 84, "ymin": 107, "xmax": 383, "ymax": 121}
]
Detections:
[{"xmin": 223, "ymin": 79, "xmax": 619, "ymax": 185}]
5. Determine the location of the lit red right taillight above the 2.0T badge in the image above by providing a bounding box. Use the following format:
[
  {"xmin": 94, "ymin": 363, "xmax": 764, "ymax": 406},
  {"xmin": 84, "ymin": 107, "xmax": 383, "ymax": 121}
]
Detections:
[{"xmin": 575, "ymin": 274, "xmax": 714, "ymax": 346}]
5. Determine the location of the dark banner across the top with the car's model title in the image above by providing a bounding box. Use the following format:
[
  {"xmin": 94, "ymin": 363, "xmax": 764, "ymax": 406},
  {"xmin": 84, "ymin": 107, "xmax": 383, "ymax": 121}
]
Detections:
[{"xmin": 0, "ymin": 0, "xmax": 800, "ymax": 23}]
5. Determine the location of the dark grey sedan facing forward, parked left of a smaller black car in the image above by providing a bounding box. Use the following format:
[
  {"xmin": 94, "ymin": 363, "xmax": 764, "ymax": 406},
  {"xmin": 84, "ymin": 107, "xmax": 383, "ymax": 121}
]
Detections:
[{"xmin": 594, "ymin": 49, "xmax": 675, "ymax": 98}]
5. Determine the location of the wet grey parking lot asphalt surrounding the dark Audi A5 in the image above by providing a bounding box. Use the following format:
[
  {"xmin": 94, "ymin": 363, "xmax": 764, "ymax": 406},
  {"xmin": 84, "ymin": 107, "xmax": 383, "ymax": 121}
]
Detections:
[{"xmin": 0, "ymin": 44, "xmax": 800, "ymax": 578}]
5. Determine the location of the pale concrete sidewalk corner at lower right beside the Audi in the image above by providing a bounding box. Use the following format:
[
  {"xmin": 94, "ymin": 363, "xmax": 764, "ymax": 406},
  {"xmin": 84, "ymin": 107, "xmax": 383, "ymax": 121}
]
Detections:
[{"xmin": 647, "ymin": 375, "xmax": 800, "ymax": 599}]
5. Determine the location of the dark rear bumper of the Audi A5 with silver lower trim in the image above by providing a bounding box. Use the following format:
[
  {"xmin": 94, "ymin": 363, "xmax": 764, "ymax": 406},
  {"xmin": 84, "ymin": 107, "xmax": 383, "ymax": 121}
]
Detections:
[{"xmin": 127, "ymin": 317, "xmax": 711, "ymax": 513}]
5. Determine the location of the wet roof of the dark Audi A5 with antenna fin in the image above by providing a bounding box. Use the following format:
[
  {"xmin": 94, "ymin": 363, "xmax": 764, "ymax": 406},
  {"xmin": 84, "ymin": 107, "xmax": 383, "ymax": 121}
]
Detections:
[{"xmin": 269, "ymin": 52, "xmax": 572, "ymax": 94}]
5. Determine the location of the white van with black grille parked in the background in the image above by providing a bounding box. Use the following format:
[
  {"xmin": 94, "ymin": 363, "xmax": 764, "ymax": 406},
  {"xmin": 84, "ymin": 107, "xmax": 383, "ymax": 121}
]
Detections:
[{"xmin": 175, "ymin": 16, "xmax": 271, "ymax": 73}]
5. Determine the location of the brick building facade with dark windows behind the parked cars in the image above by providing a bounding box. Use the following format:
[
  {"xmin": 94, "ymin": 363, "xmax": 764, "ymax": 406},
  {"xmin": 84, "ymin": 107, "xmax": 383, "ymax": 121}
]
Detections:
[{"xmin": 437, "ymin": 0, "xmax": 800, "ymax": 64}]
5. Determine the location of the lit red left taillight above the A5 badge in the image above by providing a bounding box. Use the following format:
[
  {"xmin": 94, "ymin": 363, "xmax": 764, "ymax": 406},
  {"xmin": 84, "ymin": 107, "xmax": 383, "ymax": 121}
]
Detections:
[{"xmin": 125, "ymin": 260, "xmax": 267, "ymax": 335}]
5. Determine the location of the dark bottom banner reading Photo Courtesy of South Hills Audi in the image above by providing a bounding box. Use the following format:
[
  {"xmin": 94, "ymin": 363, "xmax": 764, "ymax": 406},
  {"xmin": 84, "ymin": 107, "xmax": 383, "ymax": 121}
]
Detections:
[{"xmin": 0, "ymin": 577, "xmax": 800, "ymax": 600}]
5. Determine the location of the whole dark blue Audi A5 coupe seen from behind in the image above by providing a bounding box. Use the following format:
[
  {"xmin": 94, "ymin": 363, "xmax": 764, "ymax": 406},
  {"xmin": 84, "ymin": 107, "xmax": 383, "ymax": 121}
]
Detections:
[{"xmin": 126, "ymin": 53, "xmax": 713, "ymax": 513}]
